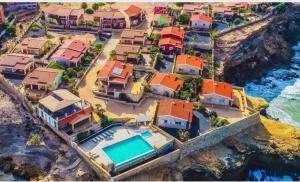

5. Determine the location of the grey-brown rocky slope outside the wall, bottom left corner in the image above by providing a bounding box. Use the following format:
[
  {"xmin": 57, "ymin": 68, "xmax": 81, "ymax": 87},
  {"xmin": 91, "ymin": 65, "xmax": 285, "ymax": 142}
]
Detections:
[{"xmin": 0, "ymin": 90, "xmax": 99, "ymax": 181}]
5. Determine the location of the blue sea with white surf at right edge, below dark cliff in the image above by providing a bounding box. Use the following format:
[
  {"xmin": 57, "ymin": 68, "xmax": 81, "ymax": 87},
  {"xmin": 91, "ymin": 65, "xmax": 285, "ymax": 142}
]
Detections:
[{"xmin": 245, "ymin": 41, "xmax": 300, "ymax": 128}]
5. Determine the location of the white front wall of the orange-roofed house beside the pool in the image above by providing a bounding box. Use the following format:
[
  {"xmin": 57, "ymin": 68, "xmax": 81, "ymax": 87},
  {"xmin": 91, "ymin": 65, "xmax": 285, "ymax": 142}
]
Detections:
[{"xmin": 157, "ymin": 116, "xmax": 188, "ymax": 129}]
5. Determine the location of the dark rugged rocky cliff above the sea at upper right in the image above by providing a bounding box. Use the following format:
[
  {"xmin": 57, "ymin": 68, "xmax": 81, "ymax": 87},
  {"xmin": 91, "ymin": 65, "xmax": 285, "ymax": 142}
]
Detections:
[{"xmin": 214, "ymin": 5, "xmax": 300, "ymax": 84}]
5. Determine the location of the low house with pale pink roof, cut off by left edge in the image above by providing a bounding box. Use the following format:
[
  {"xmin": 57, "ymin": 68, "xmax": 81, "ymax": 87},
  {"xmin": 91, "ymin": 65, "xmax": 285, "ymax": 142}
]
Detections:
[{"xmin": 0, "ymin": 53, "xmax": 34, "ymax": 75}]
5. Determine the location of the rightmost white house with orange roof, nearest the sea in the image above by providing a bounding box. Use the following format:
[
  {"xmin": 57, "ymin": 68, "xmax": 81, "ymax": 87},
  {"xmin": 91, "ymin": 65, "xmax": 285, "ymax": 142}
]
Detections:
[{"xmin": 202, "ymin": 80, "xmax": 233, "ymax": 106}]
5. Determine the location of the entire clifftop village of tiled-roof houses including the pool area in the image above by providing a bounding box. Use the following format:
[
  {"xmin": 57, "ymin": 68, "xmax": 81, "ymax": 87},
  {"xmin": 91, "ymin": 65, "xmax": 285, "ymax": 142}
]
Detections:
[{"xmin": 0, "ymin": 3, "xmax": 286, "ymax": 180}]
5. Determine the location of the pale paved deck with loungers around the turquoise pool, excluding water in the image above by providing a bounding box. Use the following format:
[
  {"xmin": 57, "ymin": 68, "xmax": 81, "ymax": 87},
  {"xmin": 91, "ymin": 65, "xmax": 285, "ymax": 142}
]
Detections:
[{"xmin": 80, "ymin": 126, "xmax": 169, "ymax": 170}]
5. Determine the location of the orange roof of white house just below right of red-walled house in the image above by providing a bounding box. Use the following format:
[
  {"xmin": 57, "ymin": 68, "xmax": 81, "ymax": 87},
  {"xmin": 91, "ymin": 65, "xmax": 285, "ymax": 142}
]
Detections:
[{"xmin": 176, "ymin": 54, "xmax": 204, "ymax": 70}]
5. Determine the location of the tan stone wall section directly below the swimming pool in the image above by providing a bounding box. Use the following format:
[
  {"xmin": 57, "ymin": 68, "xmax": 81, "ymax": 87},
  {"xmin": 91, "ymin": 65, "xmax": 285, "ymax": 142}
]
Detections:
[{"xmin": 112, "ymin": 149, "xmax": 180, "ymax": 181}]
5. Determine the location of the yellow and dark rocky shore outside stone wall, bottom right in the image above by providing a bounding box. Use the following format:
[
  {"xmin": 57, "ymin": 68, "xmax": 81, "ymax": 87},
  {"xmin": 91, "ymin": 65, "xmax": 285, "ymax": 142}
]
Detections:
[{"xmin": 128, "ymin": 98, "xmax": 300, "ymax": 181}]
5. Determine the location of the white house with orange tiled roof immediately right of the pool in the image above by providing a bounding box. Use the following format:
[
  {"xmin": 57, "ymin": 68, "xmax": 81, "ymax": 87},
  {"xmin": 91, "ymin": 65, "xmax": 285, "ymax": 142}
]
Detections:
[{"xmin": 156, "ymin": 99, "xmax": 193, "ymax": 129}]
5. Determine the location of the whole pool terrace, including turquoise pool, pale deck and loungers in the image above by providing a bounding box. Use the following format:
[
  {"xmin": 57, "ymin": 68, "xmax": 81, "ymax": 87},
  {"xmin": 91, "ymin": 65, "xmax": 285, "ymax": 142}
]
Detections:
[{"xmin": 79, "ymin": 125, "xmax": 173, "ymax": 173}]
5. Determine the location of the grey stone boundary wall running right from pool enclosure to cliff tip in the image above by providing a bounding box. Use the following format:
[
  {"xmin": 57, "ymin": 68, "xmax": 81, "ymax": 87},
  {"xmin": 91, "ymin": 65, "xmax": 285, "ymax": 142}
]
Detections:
[{"xmin": 180, "ymin": 112, "xmax": 260, "ymax": 158}]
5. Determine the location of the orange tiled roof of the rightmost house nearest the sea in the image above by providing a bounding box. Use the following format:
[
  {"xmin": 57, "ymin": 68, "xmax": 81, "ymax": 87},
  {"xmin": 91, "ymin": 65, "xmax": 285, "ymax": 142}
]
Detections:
[{"xmin": 202, "ymin": 80, "xmax": 233, "ymax": 99}]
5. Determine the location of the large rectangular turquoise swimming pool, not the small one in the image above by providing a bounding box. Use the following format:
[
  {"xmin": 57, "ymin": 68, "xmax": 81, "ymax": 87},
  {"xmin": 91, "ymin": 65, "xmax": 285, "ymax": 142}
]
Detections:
[{"xmin": 103, "ymin": 135, "xmax": 156, "ymax": 169}]
